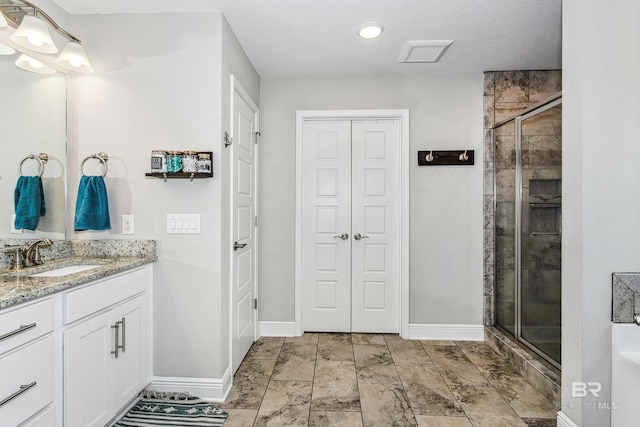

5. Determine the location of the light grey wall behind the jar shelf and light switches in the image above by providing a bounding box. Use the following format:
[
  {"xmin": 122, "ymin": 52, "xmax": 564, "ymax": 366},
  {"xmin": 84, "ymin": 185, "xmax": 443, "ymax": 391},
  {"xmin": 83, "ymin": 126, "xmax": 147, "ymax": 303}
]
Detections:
[{"xmin": 69, "ymin": 13, "xmax": 259, "ymax": 378}]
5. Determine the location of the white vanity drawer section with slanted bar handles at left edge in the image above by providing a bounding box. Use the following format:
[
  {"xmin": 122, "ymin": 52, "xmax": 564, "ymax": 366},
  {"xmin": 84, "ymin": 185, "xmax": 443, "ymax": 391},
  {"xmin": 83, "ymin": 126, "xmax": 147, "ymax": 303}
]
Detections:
[{"xmin": 0, "ymin": 298, "xmax": 55, "ymax": 426}]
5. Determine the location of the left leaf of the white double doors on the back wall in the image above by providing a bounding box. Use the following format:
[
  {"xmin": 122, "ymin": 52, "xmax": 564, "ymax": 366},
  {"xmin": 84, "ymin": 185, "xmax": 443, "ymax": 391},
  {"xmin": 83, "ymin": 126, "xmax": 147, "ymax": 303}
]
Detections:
[{"xmin": 302, "ymin": 121, "xmax": 351, "ymax": 332}]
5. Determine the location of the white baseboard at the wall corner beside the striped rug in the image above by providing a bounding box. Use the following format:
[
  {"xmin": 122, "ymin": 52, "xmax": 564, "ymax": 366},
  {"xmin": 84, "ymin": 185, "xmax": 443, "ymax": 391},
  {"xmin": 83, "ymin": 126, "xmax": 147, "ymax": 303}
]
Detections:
[{"xmin": 147, "ymin": 367, "xmax": 233, "ymax": 402}]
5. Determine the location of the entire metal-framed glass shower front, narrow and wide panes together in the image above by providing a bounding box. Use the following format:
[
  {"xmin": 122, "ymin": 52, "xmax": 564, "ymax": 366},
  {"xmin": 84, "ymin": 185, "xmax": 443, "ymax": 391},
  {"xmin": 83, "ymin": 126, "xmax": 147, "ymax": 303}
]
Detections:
[{"xmin": 494, "ymin": 98, "xmax": 562, "ymax": 368}]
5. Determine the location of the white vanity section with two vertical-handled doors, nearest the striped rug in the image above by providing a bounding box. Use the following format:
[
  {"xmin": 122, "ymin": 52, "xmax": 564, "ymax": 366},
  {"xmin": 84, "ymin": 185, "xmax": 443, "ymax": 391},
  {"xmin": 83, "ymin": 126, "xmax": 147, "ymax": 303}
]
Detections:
[{"xmin": 63, "ymin": 266, "xmax": 152, "ymax": 427}]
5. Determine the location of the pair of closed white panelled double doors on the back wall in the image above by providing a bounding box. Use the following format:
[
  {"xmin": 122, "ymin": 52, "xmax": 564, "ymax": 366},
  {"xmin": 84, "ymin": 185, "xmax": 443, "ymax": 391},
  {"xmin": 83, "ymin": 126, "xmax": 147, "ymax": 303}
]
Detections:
[{"xmin": 302, "ymin": 120, "xmax": 400, "ymax": 332}]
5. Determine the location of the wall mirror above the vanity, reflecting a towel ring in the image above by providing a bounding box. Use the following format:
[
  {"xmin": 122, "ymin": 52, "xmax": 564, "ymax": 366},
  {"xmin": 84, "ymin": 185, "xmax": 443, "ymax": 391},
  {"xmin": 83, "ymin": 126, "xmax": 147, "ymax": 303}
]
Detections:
[{"xmin": 0, "ymin": 38, "xmax": 67, "ymax": 242}]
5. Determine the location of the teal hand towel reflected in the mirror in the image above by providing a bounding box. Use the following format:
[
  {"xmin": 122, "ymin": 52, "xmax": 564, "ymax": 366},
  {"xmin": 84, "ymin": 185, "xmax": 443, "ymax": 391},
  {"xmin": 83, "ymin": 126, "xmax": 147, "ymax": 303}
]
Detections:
[{"xmin": 13, "ymin": 176, "xmax": 46, "ymax": 230}]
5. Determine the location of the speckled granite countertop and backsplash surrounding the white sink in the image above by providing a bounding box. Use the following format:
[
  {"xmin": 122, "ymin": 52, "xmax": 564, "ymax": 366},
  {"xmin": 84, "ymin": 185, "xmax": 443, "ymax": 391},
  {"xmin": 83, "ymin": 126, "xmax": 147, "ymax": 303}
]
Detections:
[{"xmin": 0, "ymin": 240, "xmax": 157, "ymax": 310}]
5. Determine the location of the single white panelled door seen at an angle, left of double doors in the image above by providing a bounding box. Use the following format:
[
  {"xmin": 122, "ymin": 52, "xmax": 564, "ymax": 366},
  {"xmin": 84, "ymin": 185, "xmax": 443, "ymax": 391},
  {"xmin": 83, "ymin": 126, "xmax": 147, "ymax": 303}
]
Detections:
[{"xmin": 231, "ymin": 84, "xmax": 258, "ymax": 372}]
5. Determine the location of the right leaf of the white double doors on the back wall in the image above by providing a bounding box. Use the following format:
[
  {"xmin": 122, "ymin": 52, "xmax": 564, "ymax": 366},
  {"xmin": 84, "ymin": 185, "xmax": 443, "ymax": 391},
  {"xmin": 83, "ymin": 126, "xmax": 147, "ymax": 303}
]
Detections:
[{"xmin": 351, "ymin": 120, "xmax": 400, "ymax": 332}]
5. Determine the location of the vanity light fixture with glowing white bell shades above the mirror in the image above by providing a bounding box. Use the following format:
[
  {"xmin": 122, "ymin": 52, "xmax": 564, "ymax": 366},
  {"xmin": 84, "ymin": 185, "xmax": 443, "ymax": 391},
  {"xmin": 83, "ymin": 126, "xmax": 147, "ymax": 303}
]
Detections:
[{"xmin": 0, "ymin": 0, "xmax": 93, "ymax": 73}]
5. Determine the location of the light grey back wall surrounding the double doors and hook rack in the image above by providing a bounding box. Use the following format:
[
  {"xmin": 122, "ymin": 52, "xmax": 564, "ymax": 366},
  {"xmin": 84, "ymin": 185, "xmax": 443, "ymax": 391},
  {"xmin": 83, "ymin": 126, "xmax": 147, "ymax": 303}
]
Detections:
[{"xmin": 259, "ymin": 74, "xmax": 483, "ymax": 325}]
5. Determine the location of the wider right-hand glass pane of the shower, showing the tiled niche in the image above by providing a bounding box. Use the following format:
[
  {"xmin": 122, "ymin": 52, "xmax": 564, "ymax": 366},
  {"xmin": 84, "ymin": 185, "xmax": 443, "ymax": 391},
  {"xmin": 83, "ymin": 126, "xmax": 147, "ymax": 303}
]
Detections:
[{"xmin": 516, "ymin": 101, "xmax": 562, "ymax": 367}]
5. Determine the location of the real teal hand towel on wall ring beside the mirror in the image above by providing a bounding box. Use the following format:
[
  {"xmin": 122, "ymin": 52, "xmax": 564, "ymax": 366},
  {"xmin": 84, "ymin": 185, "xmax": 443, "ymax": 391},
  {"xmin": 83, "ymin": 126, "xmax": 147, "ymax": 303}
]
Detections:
[{"xmin": 73, "ymin": 176, "xmax": 111, "ymax": 231}]
